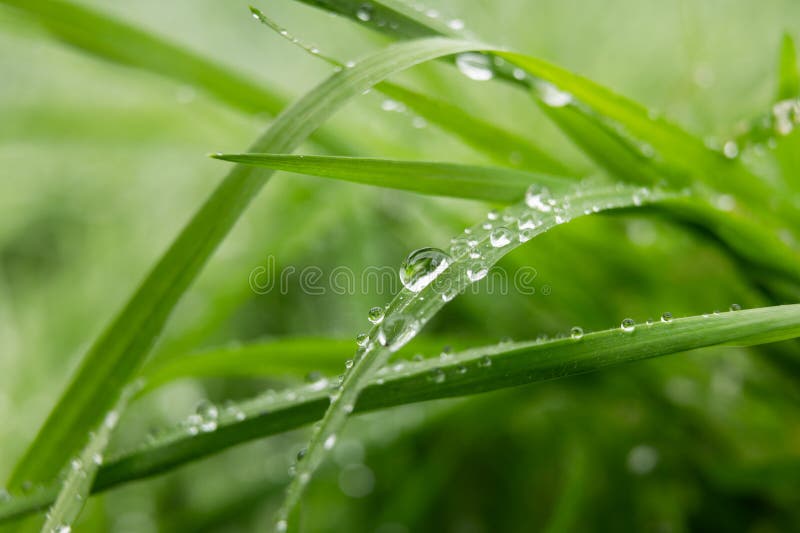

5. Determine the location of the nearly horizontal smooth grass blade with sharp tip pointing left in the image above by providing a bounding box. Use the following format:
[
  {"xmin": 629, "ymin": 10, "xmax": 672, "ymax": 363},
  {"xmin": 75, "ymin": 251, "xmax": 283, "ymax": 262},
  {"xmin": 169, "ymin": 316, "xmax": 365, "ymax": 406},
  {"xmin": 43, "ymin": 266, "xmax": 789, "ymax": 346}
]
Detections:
[{"xmin": 206, "ymin": 154, "xmax": 574, "ymax": 203}]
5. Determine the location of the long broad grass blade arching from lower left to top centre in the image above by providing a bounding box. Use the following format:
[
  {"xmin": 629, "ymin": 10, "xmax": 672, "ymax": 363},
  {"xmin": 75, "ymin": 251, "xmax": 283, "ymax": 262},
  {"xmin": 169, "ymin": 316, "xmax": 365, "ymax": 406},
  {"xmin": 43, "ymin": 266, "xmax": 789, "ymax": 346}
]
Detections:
[{"xmin": 6, "ymin": 39, "xmax": 484, "ymax": 488}]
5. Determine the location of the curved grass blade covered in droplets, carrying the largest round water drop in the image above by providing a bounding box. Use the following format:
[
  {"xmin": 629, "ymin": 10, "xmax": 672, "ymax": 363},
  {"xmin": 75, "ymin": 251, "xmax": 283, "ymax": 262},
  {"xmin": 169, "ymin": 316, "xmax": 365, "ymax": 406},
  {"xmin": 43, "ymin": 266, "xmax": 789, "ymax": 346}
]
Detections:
[{"xmin": 275, "ymin": 180, "xmax": 669, "ymax": 531}]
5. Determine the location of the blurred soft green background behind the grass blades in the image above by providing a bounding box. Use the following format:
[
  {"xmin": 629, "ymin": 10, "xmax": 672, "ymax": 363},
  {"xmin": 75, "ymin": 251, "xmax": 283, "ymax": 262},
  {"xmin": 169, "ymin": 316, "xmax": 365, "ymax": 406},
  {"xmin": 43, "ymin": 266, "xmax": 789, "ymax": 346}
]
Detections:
[{"xmin": 0, "ymin": 0, "xmax": 800, "ymax": 533}]
